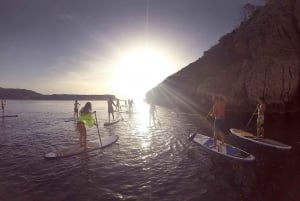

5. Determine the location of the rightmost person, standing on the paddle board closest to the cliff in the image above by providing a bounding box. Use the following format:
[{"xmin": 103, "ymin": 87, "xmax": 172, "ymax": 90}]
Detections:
[{"xmin": 256, "ymin": 97, "xmax": 266, "ymax": 138}]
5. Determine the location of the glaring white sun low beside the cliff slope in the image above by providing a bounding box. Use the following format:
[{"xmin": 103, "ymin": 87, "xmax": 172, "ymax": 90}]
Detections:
[{"xmin": 113, "ymin": 45, "xmax": 173, "ymax": 99}]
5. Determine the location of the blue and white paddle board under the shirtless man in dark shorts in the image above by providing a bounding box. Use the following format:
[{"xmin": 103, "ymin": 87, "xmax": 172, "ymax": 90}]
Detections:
[{"xmin": 189, "ymin": 133, "xmax": 255, "ymax": 162}]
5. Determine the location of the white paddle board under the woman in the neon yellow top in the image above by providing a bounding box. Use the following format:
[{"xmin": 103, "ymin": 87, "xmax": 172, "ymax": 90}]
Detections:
[{"xmin": 44, "ymin": 135, "xmax": 119, "ymax": 159}]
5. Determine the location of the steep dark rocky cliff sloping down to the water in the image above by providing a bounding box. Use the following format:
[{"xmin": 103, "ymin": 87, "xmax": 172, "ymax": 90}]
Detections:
[{"xmin": 147, "ymin": 0, "xmax": 300, "ymax": 112}]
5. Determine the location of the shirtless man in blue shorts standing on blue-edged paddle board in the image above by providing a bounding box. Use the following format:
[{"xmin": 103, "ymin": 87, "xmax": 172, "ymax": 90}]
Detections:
[{"xmin": 209, "ymin": 96, "xmax": 225, "ymax": 148}]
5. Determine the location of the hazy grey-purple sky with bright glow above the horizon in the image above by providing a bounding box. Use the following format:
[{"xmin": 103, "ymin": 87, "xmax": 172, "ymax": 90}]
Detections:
[{"xmin": 0, "ymin": 0, "xmax": 262, "ymax": 98}]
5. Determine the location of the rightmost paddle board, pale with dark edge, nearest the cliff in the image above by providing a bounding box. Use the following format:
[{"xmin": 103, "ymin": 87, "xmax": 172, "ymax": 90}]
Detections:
[{"xmin": 230, "ymin": 128, "xmax": 292, "ymax": 150}]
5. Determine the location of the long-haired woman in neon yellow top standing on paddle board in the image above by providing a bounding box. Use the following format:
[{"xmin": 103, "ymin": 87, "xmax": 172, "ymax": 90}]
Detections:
[{"xmin": 77, "ymin": 102, "xmax": 96, "ymax": 149}]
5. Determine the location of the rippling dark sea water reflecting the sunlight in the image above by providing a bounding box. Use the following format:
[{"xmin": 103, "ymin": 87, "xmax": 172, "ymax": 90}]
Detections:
[{"xmin": 0, "ymin": 100, "xmax": 300, "ymax": 201}]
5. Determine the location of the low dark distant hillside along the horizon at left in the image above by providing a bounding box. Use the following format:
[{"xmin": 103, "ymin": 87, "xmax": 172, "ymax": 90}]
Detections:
[{"xmin": 0, "ymin": 87, "xmax": 115, "ymax": 100}]
